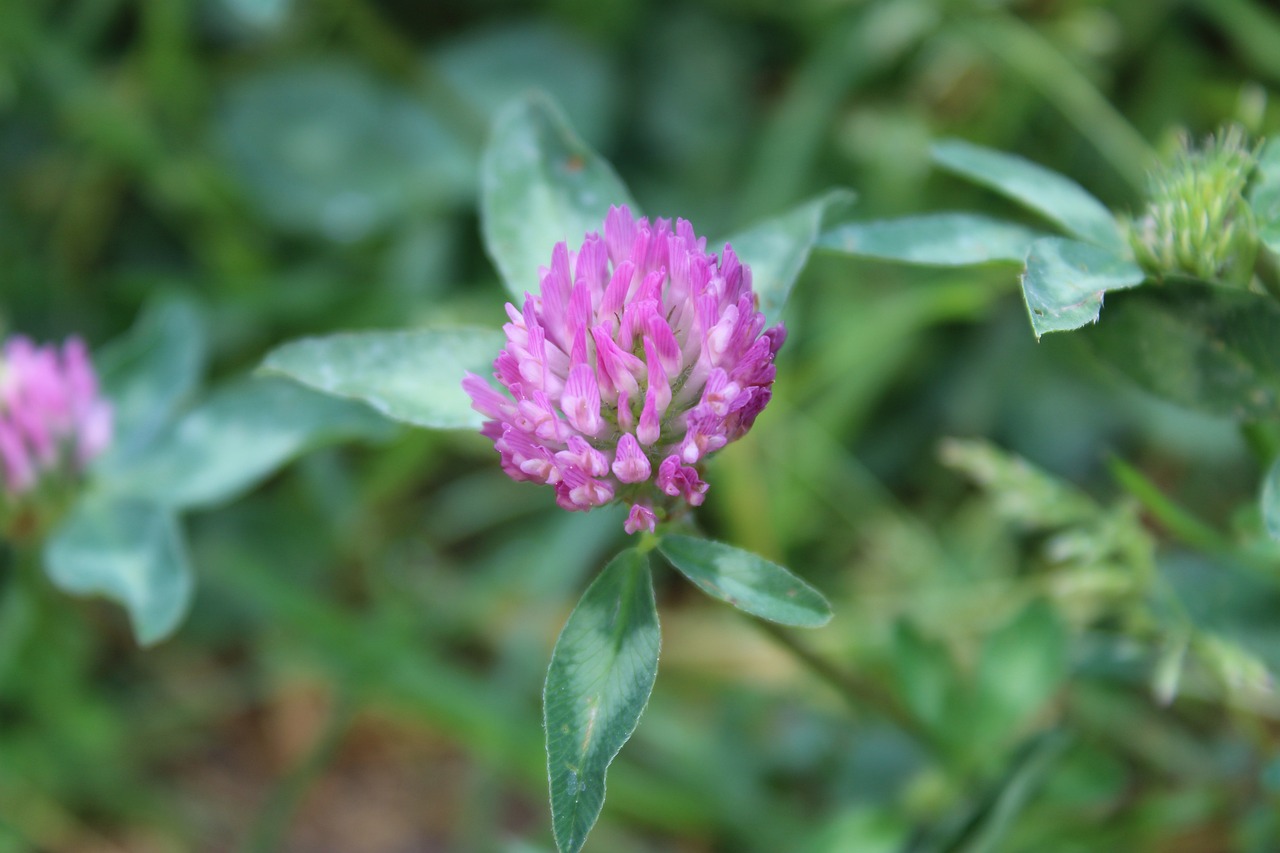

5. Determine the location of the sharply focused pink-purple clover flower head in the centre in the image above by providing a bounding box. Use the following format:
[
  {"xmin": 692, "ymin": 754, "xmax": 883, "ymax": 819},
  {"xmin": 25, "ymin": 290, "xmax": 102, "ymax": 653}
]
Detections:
[{"xmin": 462, "ymin": 206, "xmax": 786, "ymax": 533}]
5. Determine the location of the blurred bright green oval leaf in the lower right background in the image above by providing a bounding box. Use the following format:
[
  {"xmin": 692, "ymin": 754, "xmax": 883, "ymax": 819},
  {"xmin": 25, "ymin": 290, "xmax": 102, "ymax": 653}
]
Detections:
[{"xmin": 977, "ymin": 601, "xmax": 1069, "ymax": 738}]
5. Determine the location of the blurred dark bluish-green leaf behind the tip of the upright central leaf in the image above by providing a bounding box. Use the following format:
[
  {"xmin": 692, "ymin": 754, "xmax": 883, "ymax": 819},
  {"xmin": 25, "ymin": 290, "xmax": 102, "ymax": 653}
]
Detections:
[{"xmin": 434, "ymin": 19, "xmax": 618, "ymax": 142}]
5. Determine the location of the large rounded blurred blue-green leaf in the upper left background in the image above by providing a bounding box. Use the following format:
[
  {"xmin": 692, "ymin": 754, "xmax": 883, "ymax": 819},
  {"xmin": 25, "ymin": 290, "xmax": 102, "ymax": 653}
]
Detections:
[{"xmin": 216, "ymin": 63, "xmax": 475, "ymax": 241}]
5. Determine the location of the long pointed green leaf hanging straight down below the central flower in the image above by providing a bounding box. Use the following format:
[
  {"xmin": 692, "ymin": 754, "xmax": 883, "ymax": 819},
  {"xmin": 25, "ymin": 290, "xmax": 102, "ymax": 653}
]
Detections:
[{"xmin": 543, "ymin": 549, "xmax": 660, "ymax": 853}]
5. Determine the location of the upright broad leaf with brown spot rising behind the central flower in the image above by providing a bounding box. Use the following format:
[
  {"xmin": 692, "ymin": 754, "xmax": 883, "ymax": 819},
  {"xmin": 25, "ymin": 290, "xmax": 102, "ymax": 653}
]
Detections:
[{"xmin": 480, "ymin": 93, "xmax": 639, "ymax": 301}]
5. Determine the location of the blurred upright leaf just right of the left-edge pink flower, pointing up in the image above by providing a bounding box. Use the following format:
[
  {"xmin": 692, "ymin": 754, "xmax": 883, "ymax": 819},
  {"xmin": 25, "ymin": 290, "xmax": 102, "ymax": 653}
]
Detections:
[{"xmin": 95, "ymin": 298, "xmax": 206, "ymax": 466}]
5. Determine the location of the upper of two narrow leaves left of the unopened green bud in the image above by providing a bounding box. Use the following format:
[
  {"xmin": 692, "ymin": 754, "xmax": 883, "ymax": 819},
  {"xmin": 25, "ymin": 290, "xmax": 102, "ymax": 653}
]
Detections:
[{"xmin": 932, "ymin": 140, "xmax": 1125, "ymax": 252}]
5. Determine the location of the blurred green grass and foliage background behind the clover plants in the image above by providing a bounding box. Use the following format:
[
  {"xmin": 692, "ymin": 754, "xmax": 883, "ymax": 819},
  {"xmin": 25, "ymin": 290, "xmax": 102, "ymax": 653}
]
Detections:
[{"xmin": 0, "ymin": 0, "xmax": 1280, "ymax": 853}]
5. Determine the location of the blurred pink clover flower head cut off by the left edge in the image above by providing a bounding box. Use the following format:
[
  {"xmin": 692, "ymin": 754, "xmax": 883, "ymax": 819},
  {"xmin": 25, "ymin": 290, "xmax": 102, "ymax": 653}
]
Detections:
[{"xmin": 0, "ymin": 336, "xmax": 111, "ymax": 503}]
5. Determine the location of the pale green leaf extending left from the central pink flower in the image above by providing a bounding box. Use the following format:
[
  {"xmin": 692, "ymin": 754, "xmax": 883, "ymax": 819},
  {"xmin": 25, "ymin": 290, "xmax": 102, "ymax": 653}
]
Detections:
[{"xmin": 262, "ymin": 328, "xmax": 506, "ymax": 429}]
